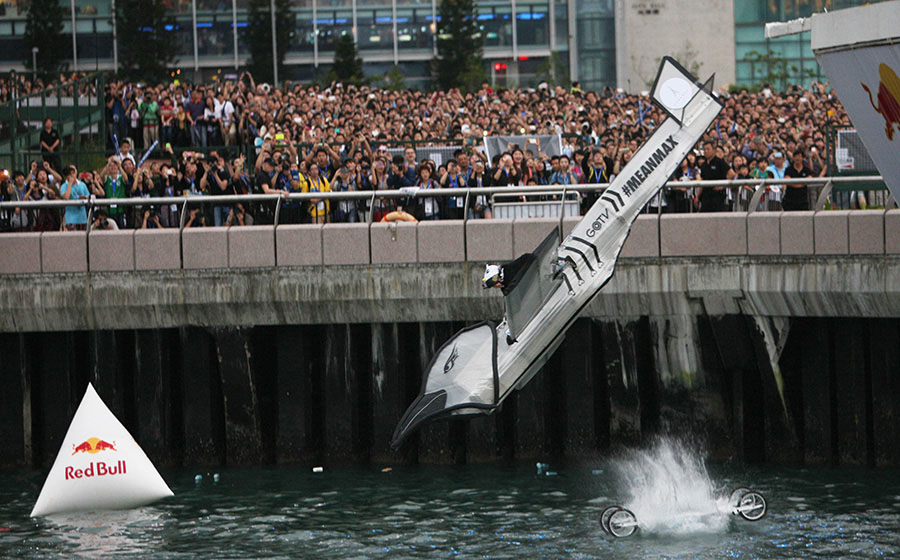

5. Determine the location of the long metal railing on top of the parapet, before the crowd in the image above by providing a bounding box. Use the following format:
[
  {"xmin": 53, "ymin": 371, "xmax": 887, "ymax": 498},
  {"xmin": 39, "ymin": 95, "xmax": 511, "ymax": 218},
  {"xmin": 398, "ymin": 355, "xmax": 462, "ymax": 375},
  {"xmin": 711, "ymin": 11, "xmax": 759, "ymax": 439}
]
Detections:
[{"xmin": 0, "ymin": 175, "xmax": 896, "ymax": 230}]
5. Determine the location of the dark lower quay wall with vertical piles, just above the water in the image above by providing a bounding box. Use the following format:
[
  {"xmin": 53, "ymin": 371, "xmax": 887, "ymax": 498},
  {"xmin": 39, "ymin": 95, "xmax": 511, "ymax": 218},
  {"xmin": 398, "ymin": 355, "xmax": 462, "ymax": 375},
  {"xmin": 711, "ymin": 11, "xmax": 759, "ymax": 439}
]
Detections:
[{"xmin": 0, "ymin": 315, "xmax": 900, "ymax": 468}]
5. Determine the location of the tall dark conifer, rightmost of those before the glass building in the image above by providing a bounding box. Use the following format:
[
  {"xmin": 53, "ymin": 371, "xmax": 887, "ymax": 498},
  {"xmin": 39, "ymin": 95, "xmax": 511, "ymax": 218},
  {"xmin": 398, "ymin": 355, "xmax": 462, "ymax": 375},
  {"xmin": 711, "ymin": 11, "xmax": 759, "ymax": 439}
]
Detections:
[{"xmin": 432, "ymin": 0, "xmax": 486, "ymax": 91}]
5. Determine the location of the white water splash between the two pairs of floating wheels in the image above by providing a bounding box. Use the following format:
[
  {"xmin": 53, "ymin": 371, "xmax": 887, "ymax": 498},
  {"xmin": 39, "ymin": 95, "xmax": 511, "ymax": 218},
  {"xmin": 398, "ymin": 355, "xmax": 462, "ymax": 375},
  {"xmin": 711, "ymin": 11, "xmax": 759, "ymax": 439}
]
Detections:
[{"xmin": 612, "ymin": 437, "xmax": 731, "ymax": 534}]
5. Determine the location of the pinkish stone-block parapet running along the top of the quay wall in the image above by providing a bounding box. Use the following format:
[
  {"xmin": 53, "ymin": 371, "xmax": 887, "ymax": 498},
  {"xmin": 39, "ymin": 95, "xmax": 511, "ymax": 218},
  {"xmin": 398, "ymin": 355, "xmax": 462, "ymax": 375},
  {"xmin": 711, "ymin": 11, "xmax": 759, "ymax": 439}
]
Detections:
[{"xmin": 0, "ymin": 210, "xmax": 900, "ymax": 277}]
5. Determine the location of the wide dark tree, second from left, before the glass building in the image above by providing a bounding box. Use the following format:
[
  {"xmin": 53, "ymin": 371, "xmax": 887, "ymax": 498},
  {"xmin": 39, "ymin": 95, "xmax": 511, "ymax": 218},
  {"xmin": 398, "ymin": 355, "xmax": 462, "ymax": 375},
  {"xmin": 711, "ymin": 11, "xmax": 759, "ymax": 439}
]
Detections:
[{"xmin": 115, "ymin": 0, "xmax": 176, "ymax": 81}]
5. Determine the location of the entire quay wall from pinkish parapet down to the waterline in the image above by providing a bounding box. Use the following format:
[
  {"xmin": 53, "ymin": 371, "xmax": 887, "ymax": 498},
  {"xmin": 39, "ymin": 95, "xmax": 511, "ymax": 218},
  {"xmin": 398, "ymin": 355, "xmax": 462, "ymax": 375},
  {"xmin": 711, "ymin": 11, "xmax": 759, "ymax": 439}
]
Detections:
[{"xmin": 0, "ymin": 211, "xmax": 900, "ymax": 467}]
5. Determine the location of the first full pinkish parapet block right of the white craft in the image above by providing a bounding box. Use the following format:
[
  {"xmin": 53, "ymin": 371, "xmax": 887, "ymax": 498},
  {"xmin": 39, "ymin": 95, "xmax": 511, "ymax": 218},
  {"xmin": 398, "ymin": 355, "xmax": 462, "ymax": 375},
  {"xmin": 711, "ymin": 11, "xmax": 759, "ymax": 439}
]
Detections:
[{"xmin": 659, "ymin": 212, "xmax": 747, "ymax": 257}]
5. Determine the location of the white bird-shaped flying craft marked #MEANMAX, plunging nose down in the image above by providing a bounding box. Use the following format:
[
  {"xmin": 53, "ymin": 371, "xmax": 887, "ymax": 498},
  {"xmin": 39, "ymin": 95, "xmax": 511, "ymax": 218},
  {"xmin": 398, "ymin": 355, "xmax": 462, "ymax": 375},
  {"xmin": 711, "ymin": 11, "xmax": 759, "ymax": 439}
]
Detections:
[{"xmin": 391, "ymin": 57, "xmax": 722, "ymax": 448}]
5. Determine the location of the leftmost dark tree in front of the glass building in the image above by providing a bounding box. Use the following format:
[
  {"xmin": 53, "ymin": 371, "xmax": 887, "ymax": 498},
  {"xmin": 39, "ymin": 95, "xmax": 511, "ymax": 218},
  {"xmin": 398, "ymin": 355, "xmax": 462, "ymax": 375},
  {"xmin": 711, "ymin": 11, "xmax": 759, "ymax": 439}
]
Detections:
[{"xmin": 23, "ymin": 0, "xmax": 72, "ymax": 72}]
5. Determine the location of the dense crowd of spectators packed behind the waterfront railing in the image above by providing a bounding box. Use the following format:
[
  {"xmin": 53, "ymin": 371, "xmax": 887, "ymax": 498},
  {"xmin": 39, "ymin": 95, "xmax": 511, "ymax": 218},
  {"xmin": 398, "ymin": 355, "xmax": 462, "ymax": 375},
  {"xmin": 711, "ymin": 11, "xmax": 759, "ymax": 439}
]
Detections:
[{"xmin": 0, "ymin": 73, "xmax": 849, "ymax": 230}]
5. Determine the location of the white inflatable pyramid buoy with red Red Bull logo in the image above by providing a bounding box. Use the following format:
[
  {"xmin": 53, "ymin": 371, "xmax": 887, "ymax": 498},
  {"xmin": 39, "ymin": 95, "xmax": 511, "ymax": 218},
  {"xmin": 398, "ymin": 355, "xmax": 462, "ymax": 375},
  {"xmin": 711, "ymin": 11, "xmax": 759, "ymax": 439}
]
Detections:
[{"xmin": 31, "ymin": 383, "xmax": 173, "ymax": 517}]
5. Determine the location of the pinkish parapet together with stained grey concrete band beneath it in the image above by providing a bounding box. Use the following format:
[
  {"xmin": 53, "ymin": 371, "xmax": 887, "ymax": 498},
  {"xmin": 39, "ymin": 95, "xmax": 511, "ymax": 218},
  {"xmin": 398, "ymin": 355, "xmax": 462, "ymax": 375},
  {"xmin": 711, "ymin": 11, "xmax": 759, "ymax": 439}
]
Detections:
[{"xmin": 0, "ymin": 210, "xmax": 900, "ymax": 332}]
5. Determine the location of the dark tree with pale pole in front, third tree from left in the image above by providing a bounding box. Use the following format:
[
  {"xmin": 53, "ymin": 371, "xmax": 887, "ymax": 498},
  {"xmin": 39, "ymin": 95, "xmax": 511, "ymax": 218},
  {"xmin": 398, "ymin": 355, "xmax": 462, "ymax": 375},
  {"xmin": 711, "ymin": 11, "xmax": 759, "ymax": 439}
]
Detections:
[{"xmin": 247, "ymin": 0, "xmax": 294, "ymax": 83}]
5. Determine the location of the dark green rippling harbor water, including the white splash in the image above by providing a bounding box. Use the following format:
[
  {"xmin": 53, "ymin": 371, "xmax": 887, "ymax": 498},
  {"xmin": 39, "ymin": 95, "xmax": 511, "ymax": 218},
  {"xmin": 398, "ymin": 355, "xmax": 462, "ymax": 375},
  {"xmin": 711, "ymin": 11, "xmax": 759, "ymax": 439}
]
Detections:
[{"xmin": 0, "ymin": 441, "xmax": 900, "ymax": 559}]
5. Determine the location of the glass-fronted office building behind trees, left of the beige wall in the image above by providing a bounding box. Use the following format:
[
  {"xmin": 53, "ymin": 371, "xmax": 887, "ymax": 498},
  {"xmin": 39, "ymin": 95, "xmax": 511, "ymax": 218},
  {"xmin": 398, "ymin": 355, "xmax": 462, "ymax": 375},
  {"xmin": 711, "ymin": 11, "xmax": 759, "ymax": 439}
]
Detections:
[{"xmin": 0, "ymin": 0, "xmax": 615, "ymax": 87}]
